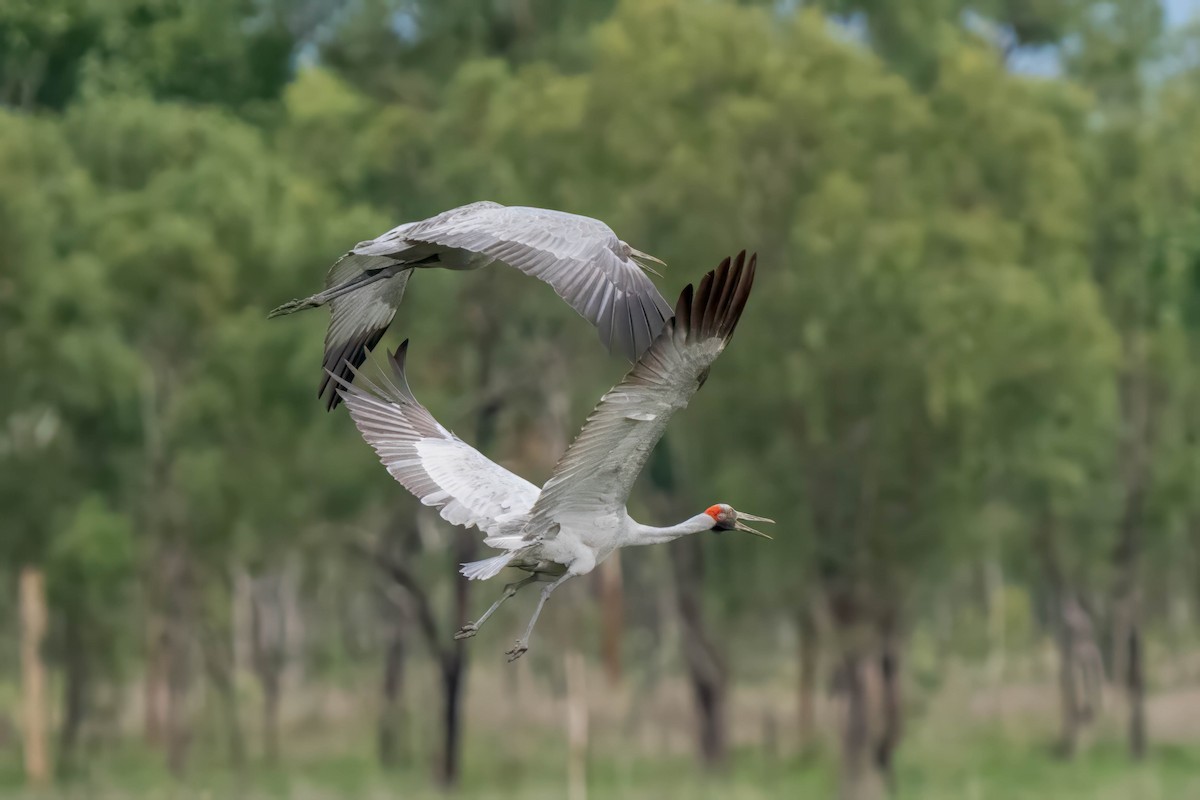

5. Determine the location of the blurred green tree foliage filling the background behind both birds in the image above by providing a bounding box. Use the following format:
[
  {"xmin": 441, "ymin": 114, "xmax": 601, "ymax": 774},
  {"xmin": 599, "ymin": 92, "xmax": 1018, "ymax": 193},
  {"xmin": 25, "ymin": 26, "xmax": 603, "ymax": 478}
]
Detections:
[{"xmin": 0, "ymin": 0, "xmax": 1200, "ymax": 796}]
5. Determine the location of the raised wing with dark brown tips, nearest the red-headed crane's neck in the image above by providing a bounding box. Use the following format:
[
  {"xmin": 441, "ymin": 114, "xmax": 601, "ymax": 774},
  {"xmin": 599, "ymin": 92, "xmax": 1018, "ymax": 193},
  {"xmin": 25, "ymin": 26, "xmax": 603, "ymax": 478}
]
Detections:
[{"xmin": 526, "ymin": 251, "xmax": 757, "ymax": 540}]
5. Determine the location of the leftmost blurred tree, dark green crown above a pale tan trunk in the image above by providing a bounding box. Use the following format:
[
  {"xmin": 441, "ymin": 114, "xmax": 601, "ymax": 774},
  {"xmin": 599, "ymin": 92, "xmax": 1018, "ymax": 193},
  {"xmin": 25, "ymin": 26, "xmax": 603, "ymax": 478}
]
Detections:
[{"xmin": 0, "ymin": 114, "xmax": 134, "ymax": 781}]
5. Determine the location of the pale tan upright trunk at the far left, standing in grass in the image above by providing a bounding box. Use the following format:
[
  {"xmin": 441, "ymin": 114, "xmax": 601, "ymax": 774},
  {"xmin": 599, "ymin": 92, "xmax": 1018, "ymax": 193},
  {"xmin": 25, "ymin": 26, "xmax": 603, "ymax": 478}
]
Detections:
[{"xmin": 19, "ymin": 566, "xmax": 50, "ymax": 787}]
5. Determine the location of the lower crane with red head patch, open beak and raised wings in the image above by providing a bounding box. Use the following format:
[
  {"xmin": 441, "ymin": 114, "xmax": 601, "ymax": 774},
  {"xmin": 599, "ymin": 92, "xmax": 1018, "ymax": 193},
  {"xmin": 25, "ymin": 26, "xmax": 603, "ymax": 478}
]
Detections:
[{"xmin": 336, "ymin": 252, "xmax": 772, "ymax": 661}]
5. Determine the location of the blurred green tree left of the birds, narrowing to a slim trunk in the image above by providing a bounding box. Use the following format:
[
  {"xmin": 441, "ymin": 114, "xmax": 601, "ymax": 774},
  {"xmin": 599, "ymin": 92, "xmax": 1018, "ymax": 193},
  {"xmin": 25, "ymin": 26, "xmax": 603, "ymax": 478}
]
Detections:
[{"xmin": 46, "ymin": 94, "xmax": 379, "ymax": 771}]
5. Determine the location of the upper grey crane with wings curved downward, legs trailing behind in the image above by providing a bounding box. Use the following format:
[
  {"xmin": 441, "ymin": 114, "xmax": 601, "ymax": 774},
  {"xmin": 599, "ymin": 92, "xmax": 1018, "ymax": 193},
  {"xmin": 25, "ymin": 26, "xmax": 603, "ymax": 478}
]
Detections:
[{"xmin": 269, "ymin": 200, "xmax": 671, "ymax": 410}]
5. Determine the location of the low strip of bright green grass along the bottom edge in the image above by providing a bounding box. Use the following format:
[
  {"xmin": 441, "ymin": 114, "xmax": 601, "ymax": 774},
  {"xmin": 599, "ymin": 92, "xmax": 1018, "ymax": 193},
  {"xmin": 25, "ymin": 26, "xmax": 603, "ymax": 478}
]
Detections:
[{"xmin": 0, "ymin": 734, "xmax": 1200, "ymax": 800}]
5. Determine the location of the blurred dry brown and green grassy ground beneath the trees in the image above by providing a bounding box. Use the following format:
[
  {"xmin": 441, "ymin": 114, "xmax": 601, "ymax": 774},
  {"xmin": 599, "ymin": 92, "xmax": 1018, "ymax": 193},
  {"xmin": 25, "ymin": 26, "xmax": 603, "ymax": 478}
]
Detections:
[{"xmin": 0, "ymin": 669, "xmax": 1200, "ymax": 800}]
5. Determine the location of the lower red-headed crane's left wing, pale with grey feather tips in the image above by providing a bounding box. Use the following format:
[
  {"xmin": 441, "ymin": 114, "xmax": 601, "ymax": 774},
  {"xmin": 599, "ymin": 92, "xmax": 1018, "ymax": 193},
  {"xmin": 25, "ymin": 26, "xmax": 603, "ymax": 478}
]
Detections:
[{"xmin": 336, "ymin": 339, "xmax": 538, "ymax": 536}]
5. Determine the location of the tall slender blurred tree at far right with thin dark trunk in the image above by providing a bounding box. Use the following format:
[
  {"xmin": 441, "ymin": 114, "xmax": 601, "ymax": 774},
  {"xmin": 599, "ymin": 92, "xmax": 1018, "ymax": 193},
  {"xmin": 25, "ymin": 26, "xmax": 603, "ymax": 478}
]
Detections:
[{"xmin": 1067, "ymin": 0, "xmax": 1183, "ymax": 758}]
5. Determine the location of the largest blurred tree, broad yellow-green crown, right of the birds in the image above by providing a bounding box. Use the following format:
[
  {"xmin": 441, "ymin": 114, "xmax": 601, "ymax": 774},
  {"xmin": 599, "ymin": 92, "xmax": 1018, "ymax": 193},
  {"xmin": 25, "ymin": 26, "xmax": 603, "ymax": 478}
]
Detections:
[{"xmin": 530, "ymin": 1, "xmax": 1118, "ymax": 796}]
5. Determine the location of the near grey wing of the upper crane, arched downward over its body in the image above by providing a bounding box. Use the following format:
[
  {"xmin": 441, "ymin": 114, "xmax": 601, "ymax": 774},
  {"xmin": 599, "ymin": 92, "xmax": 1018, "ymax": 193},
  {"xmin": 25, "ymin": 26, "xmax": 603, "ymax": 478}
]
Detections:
[{"xmin": 384, "ymin": 204, "xmax": 671, "ymax": 361}]
